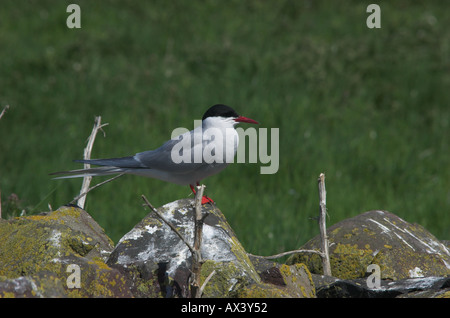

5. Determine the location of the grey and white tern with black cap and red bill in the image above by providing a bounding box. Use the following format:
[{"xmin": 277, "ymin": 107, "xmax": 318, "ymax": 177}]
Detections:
[{"xmin": 50, "ymin": 104, "xmax": 259, "ymax": 205}]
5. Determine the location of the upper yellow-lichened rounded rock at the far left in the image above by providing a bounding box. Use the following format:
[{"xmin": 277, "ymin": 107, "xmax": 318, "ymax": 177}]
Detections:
[{"xmin": 0, "ymin": 206, "xmax": 113, "ymax": 276}]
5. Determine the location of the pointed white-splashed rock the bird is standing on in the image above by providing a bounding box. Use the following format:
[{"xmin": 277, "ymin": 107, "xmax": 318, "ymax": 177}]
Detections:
[{"xmin": 107, "ymin": 199, "xmax": 261, "ymax": 297}]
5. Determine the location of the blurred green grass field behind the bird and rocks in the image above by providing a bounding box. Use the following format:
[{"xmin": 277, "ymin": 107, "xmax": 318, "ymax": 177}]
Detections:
[{"xmin": 0, "ymin": 0, "xmax": 450, "ymax": 255}]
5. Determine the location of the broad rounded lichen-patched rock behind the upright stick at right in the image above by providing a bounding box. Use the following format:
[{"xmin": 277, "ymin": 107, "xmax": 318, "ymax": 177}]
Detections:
[{"xmin": 286, "ymin": 211, "xmax": 450, "ymax": 280}]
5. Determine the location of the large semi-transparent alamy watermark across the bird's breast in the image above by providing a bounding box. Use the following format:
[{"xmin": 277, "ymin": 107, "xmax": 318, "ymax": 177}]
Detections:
[{"xmin": 171, "ymin": 120, "xmax": 280, "ymax": 174}]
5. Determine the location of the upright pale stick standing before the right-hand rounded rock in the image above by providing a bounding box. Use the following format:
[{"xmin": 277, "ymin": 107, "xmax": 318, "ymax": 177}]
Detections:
[{"xmin": 317, "ymin": 173, "xmax": 331, "ymax": 276}]
